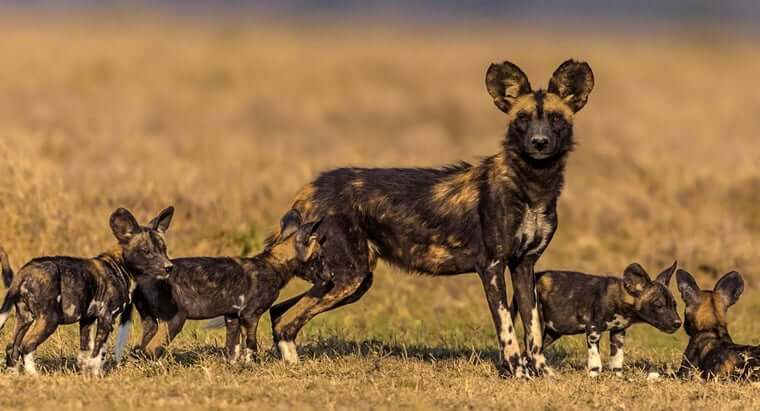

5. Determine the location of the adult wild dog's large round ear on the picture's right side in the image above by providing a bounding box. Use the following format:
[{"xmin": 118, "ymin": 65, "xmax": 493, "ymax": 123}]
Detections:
[{"xmin": 547, "ymin": 60, "xmax": 594, "ymax": 113}]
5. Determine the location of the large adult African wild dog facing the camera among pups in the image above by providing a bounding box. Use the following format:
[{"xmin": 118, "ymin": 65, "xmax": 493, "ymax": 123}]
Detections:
[{"xmin": 271, "ymin": 60, "xmax": 594, "ymax": 375}]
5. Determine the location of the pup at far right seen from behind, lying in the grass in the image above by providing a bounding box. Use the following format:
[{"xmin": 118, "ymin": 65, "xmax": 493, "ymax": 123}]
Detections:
[{"xmin": 676, "ymin": 270, "xmax": 760, "ymax": 379}]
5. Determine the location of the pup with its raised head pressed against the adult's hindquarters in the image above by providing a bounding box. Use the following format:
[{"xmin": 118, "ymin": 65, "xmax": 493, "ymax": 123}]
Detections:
[{"xmin": 117, "ymin": 211, "xmax": 329, "ymax": 362}]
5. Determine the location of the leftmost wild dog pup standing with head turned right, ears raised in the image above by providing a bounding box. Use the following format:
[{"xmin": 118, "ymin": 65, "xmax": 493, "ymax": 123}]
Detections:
[{"xmin": 0, "ymin": 207, "xmax": 174, "ymax": 375}]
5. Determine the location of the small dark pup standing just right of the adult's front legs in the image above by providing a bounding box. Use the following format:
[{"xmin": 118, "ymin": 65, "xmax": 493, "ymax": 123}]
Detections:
[{"xmin": 512, "ymin": 262, "xmax": 681, "ymax": 377}]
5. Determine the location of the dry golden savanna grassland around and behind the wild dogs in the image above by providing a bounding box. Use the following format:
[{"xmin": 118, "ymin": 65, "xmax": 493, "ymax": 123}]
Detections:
[{"xmin": 0, "ymin": 12, "xmax": 760, "ymax": 410}]
